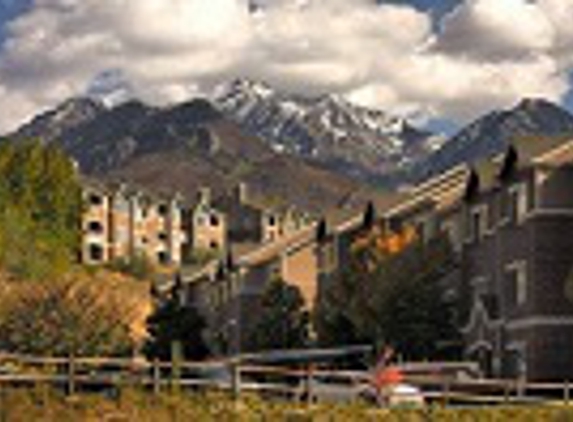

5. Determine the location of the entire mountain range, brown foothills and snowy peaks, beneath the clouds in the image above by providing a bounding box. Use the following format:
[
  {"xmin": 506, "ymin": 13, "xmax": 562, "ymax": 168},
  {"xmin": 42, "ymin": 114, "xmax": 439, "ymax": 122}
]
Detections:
[{"xmin": 4, "ymin": 80, "xmax": 573, "ymax": 213}]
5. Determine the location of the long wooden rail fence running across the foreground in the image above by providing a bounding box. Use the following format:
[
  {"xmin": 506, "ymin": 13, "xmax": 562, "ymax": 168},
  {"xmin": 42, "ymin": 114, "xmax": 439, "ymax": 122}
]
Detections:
[{"xmin": 0, "ymin": 354, "xmax": 571, "ymax": 405}]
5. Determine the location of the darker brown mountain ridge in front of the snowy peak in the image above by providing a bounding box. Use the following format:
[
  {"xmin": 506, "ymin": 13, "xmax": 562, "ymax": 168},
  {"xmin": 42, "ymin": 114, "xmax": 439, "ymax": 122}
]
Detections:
[{"xmin": 7, "ymin": 98, "xmax": 382, "ymax": 213}]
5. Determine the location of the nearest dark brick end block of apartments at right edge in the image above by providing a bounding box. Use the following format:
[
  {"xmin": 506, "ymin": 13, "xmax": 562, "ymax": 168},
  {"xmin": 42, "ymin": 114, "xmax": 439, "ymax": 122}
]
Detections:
[{"xmin": 446, "ymin": 139, "xmax": 573, "ymax": 380}]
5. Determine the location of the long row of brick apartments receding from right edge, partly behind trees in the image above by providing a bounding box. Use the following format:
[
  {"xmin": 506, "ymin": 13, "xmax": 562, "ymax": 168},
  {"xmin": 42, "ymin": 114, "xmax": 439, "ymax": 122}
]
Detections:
[{"xmin": 179, "ymin": 139, "xmax": 573, "ymax": 380}]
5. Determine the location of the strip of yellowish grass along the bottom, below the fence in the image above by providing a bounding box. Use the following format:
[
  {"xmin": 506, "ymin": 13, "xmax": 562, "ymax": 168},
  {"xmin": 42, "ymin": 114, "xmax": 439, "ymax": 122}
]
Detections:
[{"xmin": 0, "ymin": 387, "xmax": 573, "ymax": 422}]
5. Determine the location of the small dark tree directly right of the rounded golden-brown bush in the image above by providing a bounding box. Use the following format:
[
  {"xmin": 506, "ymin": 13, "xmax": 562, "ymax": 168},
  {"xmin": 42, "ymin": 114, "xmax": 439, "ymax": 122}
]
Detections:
[{"xmin": 143, "ymin": 293, "xmax": 209, "ymax": 361}]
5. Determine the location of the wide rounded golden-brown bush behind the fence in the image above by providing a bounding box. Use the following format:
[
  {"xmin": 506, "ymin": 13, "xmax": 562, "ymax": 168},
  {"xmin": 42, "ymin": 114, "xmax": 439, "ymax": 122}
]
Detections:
[{"xmin": 0, "ymin": 282, "xmax": 133, "ymax": 356}]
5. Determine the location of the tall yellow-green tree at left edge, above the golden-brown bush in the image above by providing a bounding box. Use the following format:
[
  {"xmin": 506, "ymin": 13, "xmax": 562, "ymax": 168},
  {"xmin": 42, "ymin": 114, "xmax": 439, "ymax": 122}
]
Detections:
[{"xmin": 0, "ymin": 142, "xmax": 81, "ymax": 279}]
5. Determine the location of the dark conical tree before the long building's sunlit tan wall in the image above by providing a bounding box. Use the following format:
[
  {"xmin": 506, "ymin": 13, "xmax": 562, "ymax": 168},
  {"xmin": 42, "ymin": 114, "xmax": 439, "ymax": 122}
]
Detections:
[{"xmin": 249, "ymin": 280, "xmax": 310, "ymax": 350}]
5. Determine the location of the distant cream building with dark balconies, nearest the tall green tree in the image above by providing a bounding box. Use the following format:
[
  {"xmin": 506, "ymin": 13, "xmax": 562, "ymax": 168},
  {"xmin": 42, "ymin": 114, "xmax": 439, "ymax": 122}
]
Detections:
[{"xmin": 81, "ymin": 181, "xmax": 187, "ymax": 266}]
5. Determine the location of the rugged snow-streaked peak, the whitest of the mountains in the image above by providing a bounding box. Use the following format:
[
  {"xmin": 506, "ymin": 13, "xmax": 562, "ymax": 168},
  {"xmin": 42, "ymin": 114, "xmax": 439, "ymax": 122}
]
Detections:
[{"xmin": 214, "ymin": 80, "xmax": 443, "ymax": 181}]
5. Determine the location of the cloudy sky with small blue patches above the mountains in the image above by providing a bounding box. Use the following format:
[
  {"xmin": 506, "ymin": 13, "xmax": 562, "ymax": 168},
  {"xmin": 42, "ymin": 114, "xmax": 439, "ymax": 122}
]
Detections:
[{"xmin": 0, "ymin": 0, "xmax": 573, "ymax": 132}]
